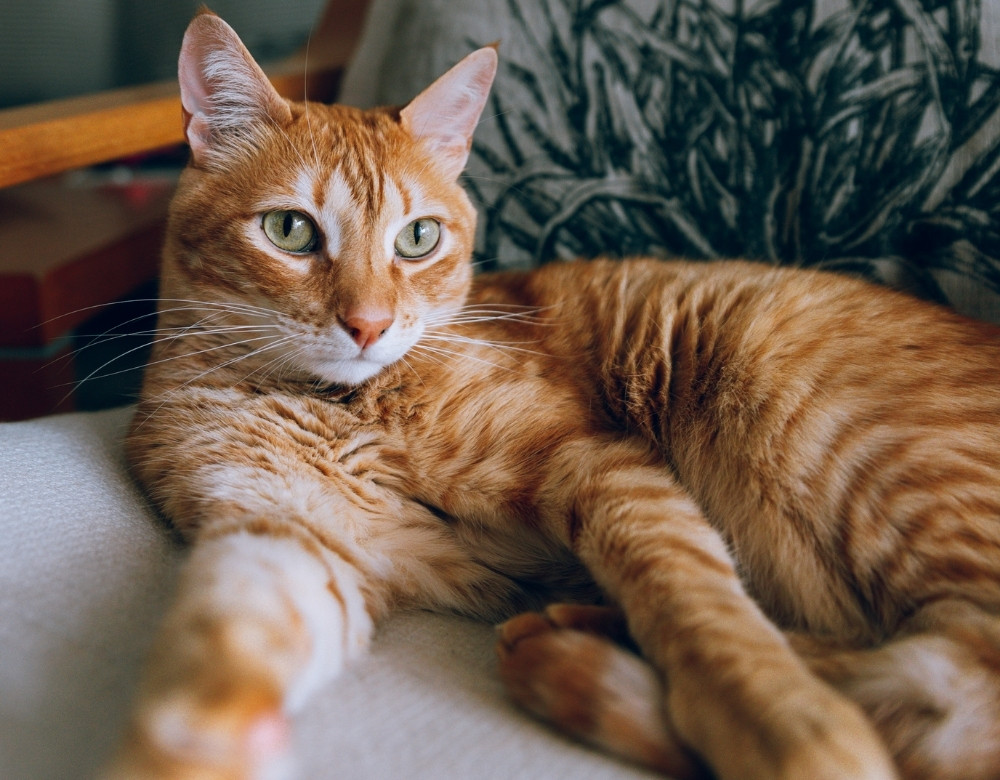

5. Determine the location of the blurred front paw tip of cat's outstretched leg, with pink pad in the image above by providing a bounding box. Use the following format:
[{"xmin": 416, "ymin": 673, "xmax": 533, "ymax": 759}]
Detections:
[{"xmin": 104, "ymin": 672, "xmax": 291, "ymax": 780}]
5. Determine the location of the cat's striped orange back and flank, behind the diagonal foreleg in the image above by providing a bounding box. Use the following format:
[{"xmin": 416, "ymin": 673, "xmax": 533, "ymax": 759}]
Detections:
[{"xmin": 496, "ymin": 261, "xmax": 1000, "ymax": 635}]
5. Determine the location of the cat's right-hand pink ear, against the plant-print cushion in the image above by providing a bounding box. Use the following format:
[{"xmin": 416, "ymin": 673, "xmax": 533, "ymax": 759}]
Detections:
[{"xmin": 400, "ymin": 46, "xmax": 497, "ymax": 179}]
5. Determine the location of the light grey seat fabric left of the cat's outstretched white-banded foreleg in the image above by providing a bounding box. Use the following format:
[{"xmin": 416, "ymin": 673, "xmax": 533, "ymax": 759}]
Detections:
[{"xmin": 0, "ymin": 410, "xmax": 181, "ymax": 780}]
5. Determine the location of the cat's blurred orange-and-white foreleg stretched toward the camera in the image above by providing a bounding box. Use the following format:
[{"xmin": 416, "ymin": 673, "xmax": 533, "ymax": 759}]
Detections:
[{"xmin": 107, "ymin": 528, "xmax": 372, "ymax": 778}]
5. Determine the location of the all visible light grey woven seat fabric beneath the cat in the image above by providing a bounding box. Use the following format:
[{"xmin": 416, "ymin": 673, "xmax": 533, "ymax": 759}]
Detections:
[{"xmin": 0, "ymin": 409, "xmax": 647, "ymax": 780}]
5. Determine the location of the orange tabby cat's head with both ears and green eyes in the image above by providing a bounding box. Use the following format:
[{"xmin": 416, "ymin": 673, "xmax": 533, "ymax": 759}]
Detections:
[{"xmin": 162, "ymin": 13, "xmax": 497, "ymax": 385}]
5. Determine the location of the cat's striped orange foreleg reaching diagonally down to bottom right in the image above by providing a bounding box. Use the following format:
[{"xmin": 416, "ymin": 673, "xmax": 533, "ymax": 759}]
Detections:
[{"xmin": 552, "ymin": 444, "xmax": 896, "ymax": 780}]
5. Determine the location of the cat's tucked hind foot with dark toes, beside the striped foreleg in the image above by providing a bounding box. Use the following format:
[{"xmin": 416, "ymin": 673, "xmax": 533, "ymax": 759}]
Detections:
[{"xmin": 497, "ymin": 604, "xmax": 710, "ymax": 780}]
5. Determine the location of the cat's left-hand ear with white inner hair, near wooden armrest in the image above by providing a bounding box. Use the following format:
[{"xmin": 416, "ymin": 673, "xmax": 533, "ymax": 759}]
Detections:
[{"xmin": 177, "ymin": 11, "xmax": 292, "ymax": 167}]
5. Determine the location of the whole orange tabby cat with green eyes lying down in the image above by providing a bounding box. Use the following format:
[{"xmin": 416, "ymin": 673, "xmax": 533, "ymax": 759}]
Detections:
[{"xmin": 112, "ymin": 14, "xmax": 1000, "ymax": 780}]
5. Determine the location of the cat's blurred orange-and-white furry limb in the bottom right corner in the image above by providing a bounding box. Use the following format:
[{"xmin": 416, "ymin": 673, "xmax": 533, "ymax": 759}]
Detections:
[{"xmin": 790, "ymin": 600, "xmax": 1000, "ymax": 780}]
